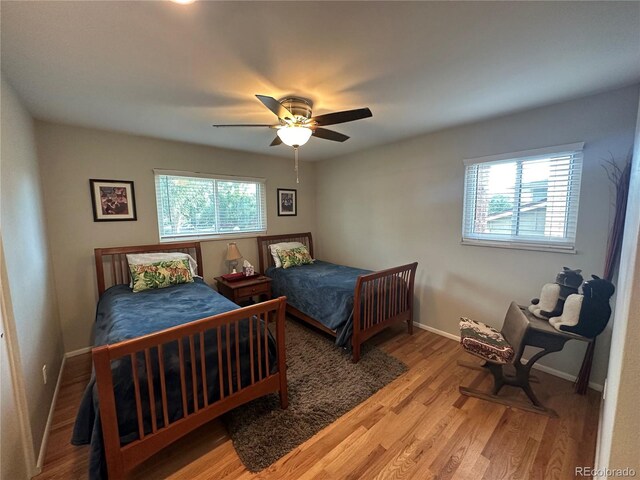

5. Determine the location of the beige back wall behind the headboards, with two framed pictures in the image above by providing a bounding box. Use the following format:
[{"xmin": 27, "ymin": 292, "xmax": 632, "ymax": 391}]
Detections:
[{"xmin": 36, "ymin": 122, "xmax": 316, "ymax": 351}]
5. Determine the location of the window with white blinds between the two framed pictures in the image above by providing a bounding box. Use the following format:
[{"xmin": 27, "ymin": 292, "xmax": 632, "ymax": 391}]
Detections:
[{"xmin": 154, "ymin": 170, "xmax": 267, "ymax": 241}]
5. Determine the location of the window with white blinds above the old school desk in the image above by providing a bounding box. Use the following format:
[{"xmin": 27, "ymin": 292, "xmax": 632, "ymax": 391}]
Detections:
[{"xmin": 462, "ymin": 143, "xmax": 584, "ymax": 251}]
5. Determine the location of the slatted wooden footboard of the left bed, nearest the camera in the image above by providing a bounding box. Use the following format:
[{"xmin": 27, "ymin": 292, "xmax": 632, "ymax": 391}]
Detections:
[{"xmin": 93, "ymin": 297, "xmax": 287, "ymax": 480}]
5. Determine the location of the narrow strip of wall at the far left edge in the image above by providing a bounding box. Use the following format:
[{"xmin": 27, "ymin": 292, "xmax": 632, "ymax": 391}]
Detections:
[{"xmin": 0, "ymin": 79, "xmax": 64, "ymax": 464}]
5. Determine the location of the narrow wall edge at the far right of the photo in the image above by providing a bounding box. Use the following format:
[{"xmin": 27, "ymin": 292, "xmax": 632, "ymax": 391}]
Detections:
[{"xmin": 597, "ymin": 91, "xmax": 640, "ymax": 472}]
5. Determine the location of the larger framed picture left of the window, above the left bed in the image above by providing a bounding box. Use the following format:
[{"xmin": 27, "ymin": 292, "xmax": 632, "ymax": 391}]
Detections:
[{"xmin": 89, "ymin": 178, "xmax": 137, "ymax": 222}]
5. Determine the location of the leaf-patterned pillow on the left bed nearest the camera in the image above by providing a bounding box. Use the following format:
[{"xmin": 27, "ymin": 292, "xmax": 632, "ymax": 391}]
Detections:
[{"xmin": 129, "ymin": 259, "xmax": 193, "ymax": 292}]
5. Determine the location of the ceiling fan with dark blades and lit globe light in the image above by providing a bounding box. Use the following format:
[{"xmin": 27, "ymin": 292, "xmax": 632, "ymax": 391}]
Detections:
[{"xmin": 213, "ymin": 95, "xmax": 373, "ymax": 183}]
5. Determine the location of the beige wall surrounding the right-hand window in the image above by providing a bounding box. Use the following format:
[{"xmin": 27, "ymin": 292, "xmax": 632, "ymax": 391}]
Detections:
[{"xmin": 316, "ymin": 87, "xmax": 638, "ymax": 384}]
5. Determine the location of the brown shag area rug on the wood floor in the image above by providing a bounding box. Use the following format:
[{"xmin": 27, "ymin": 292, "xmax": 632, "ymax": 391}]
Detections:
[{"xmin": 223, "ymin": 320, "xmax": 407, "ymax": 472}]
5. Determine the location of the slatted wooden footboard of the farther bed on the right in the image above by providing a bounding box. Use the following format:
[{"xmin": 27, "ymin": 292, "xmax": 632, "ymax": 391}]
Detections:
[{"xmin": 351, "ymin": 262, "xmax": 418, "ymax": 363}]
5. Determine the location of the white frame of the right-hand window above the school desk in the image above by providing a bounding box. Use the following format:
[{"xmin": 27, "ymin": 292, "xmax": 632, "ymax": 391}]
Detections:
[{"xmin": 461, "ymin": 142, "xmax": 584, "ymax": 253}]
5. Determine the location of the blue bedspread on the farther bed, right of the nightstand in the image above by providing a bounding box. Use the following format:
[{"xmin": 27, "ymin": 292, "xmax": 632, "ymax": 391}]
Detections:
[{"xmin": 265, "ymin": 260, "xmax": 371, "ymax": 346}]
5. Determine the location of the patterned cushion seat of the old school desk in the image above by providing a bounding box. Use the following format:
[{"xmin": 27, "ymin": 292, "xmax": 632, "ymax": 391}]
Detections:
[{"xmin": 460, "ymin": 317, "xmax": 515, "ymax": 364}]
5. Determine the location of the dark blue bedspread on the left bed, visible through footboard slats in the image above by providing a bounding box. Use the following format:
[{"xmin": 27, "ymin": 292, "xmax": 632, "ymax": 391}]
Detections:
[{"xmin": 72, "ymin": 279, "xmax": 277, "ymax": 479}]
